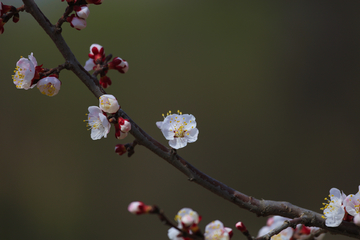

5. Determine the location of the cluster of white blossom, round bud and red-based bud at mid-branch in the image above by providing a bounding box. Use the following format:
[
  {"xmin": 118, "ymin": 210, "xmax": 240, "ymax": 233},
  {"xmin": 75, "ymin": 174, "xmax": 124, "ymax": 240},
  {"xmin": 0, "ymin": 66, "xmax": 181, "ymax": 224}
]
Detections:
[{"xmin": 84, "ymin": 94, "xmax": 131, "ymax": 140}]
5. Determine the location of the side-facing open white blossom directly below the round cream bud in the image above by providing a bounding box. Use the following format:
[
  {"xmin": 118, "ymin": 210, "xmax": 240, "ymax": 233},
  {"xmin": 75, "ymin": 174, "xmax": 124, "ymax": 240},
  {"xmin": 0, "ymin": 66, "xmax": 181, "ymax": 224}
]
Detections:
[{"xmin": 87, "ymin": 106, "xmax": 111, "ymax": 140}]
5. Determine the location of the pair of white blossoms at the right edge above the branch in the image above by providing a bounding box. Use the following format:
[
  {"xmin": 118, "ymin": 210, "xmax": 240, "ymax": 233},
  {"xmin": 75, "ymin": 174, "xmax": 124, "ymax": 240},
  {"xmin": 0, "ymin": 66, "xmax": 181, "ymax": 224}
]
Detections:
[{"xmin": 321, "ymin": 186, "xmax": 360, "ymax": 227}]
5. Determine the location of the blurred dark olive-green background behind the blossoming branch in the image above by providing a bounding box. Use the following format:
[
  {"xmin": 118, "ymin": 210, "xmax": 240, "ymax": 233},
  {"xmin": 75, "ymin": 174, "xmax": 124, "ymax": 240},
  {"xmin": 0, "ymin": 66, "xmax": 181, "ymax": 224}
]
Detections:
[{"xmin": 0, "ymin": 0, "xmax": 360, "ymax": 240}]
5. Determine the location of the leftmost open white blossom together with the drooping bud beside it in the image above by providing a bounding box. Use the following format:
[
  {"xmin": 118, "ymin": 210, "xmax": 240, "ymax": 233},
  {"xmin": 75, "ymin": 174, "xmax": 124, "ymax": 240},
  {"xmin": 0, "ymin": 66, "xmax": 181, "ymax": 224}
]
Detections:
[{"xmin": 12, "ymin": 53, "xmax": 61, "ymax": 97}]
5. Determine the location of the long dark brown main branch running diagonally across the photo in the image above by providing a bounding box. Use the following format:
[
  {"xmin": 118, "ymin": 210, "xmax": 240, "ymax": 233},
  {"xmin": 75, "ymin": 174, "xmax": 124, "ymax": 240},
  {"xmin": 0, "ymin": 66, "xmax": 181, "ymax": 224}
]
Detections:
[{"xmin": 23, "ymin": 0, "xmax": 360, "ymax": 239}]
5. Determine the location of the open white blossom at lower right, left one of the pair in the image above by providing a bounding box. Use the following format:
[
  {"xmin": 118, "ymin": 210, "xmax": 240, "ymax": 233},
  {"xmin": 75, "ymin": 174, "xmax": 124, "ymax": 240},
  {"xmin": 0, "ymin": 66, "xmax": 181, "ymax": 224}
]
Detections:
[{"xmin": 322, "ymin": 188, "xmax": 346, "ymax": 227}]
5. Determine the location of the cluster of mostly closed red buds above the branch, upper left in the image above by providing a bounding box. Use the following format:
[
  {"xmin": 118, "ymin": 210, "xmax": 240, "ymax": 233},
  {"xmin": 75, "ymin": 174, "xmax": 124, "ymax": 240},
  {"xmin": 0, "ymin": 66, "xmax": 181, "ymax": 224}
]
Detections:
[{"xmin": 84, "ymin": 43, "xmax": 129, "ymax": 88}]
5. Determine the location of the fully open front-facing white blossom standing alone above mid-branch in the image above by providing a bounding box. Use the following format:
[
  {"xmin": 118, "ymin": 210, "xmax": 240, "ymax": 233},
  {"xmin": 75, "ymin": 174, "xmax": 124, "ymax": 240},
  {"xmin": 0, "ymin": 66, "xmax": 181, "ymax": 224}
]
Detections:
[{"xmin": 156, "ymin": 111, "xmax": 199, "ymax": 149}]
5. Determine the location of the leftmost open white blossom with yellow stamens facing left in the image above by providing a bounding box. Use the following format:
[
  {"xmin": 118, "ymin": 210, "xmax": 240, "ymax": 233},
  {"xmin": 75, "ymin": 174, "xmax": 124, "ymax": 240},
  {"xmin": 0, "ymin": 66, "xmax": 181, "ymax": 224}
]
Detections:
[{"xmin": 12, "ymin": 53, "xmax": 37, "ymax": 90}]
